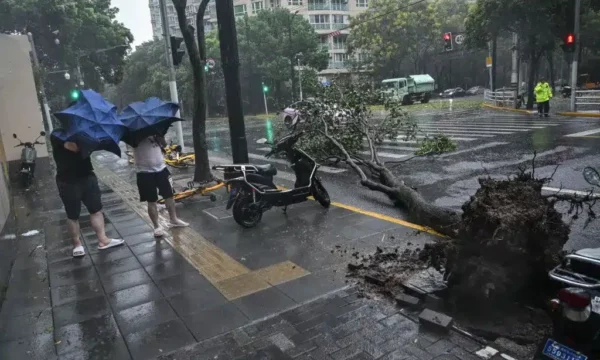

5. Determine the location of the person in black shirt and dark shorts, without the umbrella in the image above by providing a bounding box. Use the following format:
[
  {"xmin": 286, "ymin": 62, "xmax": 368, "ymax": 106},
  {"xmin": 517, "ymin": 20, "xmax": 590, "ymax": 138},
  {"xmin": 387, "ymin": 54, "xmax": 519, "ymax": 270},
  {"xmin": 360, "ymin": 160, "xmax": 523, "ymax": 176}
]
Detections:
[{"xmin": 50, "ymin": 129, "xmax": 124, "ymax": 257}]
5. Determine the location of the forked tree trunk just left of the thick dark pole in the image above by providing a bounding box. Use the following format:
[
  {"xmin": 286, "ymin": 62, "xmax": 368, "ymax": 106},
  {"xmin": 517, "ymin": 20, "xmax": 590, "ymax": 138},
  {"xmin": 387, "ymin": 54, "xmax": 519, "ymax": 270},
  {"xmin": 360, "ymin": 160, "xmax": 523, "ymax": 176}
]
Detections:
[{"xmin": 172, "ymin": 0, "xmax": 213, "ymax": 183}]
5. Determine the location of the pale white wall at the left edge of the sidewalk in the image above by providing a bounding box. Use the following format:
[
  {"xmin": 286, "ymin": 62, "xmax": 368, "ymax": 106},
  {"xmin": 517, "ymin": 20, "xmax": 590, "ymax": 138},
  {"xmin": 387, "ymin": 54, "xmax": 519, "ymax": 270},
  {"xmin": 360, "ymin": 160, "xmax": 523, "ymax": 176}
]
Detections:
[{"xmin": 0, "ymin": 34, "xmax": 48, "ymax": 161}]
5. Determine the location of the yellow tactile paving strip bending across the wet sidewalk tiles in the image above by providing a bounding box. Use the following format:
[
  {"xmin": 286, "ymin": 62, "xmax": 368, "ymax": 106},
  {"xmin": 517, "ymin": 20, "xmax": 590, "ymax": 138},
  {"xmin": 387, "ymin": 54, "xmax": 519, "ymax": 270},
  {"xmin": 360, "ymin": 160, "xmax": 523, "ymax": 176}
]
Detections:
[{"xmin": 94, "ymin": 161, "xmax": 310, "ymax": 301}]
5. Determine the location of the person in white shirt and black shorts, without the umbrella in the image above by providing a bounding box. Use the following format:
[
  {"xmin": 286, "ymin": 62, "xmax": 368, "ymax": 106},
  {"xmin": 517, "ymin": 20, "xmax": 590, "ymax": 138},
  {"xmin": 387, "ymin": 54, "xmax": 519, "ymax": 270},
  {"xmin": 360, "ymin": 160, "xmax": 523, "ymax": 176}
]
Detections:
[{"xmin": 133, "ymin": 136, "xmax": 189, "ymax": 237}]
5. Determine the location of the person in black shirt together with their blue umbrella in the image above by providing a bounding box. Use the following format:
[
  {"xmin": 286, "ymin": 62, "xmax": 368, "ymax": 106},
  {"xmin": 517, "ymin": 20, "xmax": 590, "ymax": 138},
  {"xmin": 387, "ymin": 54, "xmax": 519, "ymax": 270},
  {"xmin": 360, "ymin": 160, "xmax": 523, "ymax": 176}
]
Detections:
[{"xmin": 50, "ymin": 90, "xmax": 125, "ymax": 257}]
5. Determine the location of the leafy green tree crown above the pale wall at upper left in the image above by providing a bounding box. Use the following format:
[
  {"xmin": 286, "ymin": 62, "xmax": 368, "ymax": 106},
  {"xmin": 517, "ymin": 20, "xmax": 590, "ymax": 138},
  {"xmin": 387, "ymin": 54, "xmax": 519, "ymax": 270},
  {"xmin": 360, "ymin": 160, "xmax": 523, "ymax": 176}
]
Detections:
[{"xmin": 0, "ymin": 0, "xmax": 133, "ymax": 106}]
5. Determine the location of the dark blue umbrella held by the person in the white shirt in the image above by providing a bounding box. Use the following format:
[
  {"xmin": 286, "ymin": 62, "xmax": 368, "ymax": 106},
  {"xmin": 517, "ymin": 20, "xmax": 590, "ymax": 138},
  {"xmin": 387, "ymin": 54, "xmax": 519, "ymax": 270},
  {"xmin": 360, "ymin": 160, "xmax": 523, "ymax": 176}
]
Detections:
[{"xmin": 119, "ymin": 97, "xmax": 182, "ymax": 147}]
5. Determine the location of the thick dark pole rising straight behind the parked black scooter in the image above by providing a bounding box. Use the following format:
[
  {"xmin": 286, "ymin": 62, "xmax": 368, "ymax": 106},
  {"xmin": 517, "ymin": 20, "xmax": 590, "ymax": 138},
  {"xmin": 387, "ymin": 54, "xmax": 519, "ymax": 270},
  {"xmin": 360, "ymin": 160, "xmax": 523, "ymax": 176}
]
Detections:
[{"xmin": 215, "ymin": 0, "xmax": 248, "ymax": 164}]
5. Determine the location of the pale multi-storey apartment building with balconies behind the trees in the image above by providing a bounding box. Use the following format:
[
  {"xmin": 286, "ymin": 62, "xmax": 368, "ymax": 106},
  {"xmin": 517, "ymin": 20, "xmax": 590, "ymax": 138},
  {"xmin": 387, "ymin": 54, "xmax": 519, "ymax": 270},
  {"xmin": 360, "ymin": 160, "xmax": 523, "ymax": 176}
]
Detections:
[{"xmin": 149, "ymin": 0, "xmax": 369, "ymax": 76}]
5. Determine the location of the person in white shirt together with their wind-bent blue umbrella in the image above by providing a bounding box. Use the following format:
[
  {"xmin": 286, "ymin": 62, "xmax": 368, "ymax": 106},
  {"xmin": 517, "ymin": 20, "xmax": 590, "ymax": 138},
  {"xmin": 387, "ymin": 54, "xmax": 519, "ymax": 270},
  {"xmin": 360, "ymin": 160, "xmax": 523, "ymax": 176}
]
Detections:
[{"xmin": 119, "ymin": 98, "xmax": 189, "ymax": 238}]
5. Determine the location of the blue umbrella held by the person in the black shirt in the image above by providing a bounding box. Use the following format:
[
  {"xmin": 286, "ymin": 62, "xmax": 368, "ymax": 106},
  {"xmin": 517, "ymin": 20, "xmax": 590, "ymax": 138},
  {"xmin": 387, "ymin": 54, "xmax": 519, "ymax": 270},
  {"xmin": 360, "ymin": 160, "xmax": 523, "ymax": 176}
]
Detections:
[{"xmin": 55, "ymin": 90, "xmax": 126, "ymax": 157}]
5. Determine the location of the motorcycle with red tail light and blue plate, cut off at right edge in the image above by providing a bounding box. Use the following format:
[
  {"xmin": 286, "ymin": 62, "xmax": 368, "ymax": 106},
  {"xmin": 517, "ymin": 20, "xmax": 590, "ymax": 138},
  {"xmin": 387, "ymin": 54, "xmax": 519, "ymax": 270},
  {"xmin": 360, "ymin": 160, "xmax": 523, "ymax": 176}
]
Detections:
[{"xmin": 535, "ymin": 167, "xmax": 600, "ymax": 360}]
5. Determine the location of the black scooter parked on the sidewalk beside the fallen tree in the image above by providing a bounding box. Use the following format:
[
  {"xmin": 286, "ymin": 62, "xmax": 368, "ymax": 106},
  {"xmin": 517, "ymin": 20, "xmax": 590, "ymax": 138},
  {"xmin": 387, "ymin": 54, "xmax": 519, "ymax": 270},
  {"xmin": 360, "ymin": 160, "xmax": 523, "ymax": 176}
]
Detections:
[{"xmin": 213, "ymin": 132, "xmax": 331, "ymax": 228}]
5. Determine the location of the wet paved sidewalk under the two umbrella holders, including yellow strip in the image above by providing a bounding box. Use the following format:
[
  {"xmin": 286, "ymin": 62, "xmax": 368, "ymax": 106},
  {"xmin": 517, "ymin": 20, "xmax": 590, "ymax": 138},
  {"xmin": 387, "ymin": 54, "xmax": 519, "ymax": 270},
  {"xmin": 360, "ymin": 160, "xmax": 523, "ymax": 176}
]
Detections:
[{"xmin": 0, "ymin": 156, "xmax": 507, "ymax": 360}]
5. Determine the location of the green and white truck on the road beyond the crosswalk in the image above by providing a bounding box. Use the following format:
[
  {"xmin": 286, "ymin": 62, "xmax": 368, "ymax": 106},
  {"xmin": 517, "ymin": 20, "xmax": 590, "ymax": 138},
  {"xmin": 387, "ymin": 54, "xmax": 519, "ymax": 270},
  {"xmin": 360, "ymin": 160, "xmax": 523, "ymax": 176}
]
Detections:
[{"xmin": 382, "ymin": 74, "xmax": 435, "ymax": 105}]
